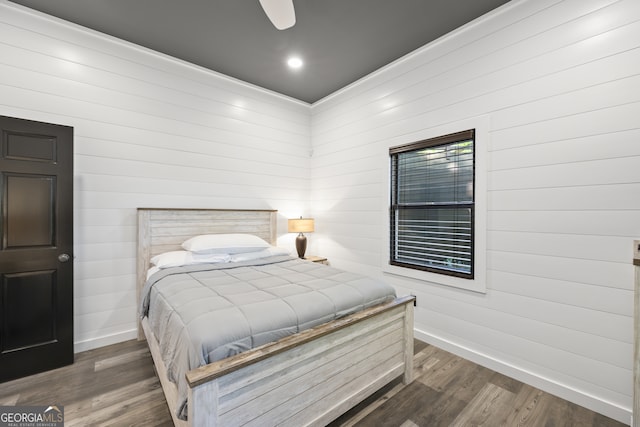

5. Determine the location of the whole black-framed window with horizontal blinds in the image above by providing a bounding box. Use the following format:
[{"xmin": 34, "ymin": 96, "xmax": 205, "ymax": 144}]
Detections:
[{"xmin": 389, "ymin": 130, "xmax": 475, "ymax": 279}]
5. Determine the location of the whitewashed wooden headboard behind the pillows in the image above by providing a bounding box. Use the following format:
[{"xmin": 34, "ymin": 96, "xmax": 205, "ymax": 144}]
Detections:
[{"xmin": 136, "ymin": 208, "xmax": 278, "ymax": 338}]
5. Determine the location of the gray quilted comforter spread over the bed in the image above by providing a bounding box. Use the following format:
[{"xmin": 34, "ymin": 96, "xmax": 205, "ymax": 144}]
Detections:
[{"xmin": 140, "ymin": 256, "xmax": 395, "ymax": 419}]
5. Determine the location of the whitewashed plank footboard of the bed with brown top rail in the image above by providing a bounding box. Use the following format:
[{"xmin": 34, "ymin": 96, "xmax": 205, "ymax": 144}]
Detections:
[{"xmin": 145, "ymin": 297, "xmax": 414, "ymax": 427}]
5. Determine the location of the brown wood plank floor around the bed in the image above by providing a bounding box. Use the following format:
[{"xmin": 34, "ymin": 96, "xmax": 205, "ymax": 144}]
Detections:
[{"xmin": 0, "ymin": 341, "xmax": 624, "ymax": 427}]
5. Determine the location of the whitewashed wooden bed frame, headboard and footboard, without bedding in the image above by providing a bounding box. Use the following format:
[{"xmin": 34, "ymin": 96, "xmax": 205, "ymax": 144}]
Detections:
[{"xmin": 137, "ymin": 208, "xmax": 414, "ymax": 427}]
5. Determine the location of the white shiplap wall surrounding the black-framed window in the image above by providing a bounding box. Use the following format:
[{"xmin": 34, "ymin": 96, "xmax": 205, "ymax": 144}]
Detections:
[{"xmin": 310, "ymin": 0, "xmax": 640, "ymax": 422}]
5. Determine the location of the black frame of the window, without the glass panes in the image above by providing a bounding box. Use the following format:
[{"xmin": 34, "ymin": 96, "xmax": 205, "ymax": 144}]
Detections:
[{"xmin": 389, "ymin": 129, "xmax": 477, "ymax": 280}]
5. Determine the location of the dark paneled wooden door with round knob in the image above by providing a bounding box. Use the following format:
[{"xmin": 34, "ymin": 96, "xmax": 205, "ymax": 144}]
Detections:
[{"xmin": 0, "ymin": 116, "xmax": 73, "ymax": 382}]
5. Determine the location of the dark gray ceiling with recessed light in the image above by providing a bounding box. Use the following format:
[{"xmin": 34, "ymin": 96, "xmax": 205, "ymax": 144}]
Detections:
[{"xmin": 12, "ymin": 0, "xmax": 508, "ymax": 103}]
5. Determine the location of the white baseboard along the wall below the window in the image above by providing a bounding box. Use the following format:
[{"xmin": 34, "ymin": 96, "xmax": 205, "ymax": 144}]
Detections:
[{"xmin": 414, "ymin": 329, "xmax": 632, "ymax": 424}]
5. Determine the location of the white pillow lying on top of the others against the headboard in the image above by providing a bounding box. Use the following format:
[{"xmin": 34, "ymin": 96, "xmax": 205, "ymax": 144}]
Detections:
[{"xmin": 182, "ymin": 234, "xmax": 271, "ymax": 254}]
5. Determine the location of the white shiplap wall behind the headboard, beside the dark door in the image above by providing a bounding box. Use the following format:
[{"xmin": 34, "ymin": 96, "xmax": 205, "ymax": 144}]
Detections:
[{"xmin": 0, "ymin": 1, "xmax": 310, "ymax": 351}]
